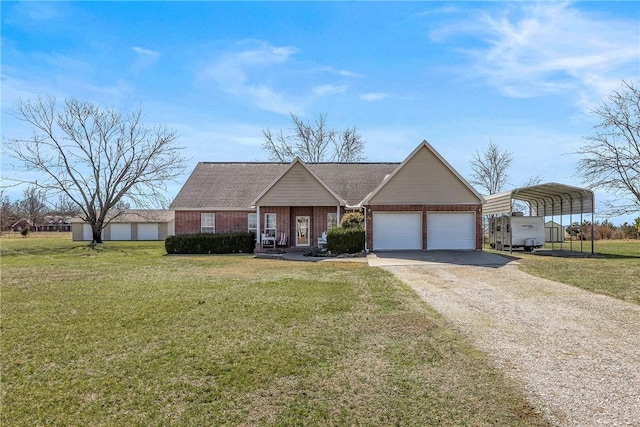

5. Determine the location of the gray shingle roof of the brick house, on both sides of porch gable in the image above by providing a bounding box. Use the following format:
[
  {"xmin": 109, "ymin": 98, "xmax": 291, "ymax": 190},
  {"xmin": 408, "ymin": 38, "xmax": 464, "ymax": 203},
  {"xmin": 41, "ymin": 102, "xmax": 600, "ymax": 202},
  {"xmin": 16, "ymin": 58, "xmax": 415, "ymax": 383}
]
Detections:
[{"xmin": 170, "ymin": 162, "xmax": 400, "ymax": 210}]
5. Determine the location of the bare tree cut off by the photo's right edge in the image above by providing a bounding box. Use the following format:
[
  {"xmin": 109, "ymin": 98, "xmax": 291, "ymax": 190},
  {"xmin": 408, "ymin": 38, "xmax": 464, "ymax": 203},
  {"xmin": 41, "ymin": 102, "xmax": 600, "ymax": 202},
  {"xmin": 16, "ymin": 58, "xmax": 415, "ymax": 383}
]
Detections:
[{"xmin": 577, "ymin": 81, "xmax": 640, "ymax": 215}]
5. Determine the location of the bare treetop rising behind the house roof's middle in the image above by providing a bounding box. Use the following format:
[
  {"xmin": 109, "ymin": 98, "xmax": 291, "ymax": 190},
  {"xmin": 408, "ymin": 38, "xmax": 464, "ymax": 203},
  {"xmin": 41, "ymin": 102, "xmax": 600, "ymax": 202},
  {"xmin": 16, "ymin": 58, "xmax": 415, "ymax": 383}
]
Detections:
[{"xmin": 262, "ymin": 114, "xmax": 365, "ymax": 163}]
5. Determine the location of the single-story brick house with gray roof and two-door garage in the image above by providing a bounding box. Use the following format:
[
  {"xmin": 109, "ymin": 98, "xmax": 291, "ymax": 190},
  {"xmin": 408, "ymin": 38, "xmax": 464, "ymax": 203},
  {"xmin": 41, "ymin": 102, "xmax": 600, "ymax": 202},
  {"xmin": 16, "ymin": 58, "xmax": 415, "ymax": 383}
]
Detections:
[{"xmin": 170, "ymin": 141, "xmax": 484, "ymax": 251}]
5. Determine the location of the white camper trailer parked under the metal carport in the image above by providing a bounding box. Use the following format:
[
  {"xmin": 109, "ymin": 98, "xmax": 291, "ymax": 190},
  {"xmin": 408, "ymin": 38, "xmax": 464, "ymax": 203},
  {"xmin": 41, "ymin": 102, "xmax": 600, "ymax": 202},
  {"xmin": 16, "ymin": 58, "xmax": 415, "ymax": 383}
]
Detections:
[{"xmin": 489, "ymin": 212, "xmax": 545, "ymax": 252}]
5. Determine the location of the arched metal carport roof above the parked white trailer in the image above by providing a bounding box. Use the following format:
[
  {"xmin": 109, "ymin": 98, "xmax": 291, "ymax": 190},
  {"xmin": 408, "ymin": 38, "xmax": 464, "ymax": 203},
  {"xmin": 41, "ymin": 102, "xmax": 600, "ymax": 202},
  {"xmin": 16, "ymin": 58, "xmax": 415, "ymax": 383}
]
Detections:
[{"xmin": 482, "ymin": 182, "xmax": 595, "ymax": 216}]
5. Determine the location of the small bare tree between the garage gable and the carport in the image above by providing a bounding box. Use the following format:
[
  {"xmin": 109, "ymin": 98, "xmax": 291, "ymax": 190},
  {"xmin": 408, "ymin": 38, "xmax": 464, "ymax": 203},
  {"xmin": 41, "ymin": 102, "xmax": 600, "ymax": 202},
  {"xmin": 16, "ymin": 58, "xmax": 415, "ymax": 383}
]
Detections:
[{"xmin": 470, "ymin": 141, "xmax": 513, "ymax": 195}]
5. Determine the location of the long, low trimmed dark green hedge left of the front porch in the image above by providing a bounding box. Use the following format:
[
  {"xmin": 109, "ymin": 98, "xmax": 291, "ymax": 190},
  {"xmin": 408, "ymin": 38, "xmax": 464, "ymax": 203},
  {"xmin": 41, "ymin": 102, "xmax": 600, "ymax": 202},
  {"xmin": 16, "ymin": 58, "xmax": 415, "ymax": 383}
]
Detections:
[{"xmin": 164, "ymin": 232, "xmax": 255, "ymax": 254}]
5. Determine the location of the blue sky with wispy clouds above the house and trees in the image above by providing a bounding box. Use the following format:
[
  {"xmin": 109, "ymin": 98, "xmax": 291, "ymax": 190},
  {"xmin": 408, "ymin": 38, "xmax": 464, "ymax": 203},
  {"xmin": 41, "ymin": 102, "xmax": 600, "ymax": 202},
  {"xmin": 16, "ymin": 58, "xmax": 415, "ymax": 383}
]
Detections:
[{"xmin": 0, "ymin": 1, "xmax": 640, "ymax": 223}]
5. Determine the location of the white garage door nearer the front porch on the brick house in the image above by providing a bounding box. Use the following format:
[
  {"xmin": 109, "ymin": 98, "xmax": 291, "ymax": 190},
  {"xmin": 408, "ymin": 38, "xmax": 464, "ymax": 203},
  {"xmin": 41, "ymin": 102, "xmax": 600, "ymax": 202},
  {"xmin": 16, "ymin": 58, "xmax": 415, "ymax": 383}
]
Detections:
[{"xmin": 373, "ymin": 212, "xmax": 422, "ymax": 250}]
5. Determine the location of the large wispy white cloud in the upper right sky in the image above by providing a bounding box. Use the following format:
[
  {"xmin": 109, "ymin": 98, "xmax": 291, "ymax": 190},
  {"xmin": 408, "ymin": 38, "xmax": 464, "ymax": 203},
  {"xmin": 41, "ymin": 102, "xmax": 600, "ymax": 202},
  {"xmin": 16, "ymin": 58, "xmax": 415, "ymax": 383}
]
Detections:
[{"xmin": 431, "ymin": 2, "xmax": 640, "ymax": 102}]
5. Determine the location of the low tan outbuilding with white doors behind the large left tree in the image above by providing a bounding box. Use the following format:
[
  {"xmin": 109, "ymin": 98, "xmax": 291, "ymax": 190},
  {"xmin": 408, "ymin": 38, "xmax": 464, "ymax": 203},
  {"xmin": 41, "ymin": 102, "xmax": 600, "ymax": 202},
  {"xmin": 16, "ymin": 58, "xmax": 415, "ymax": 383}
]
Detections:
[{"xmin": 70, "ymin": 209, "xmax": 175, "ymax": 241}]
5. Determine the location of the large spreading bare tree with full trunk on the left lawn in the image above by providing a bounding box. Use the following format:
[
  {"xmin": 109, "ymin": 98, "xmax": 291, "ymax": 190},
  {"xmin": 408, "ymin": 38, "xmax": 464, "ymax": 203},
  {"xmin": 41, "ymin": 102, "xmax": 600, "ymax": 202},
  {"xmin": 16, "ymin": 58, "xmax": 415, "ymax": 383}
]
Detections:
[{"xmin": 3, "ymin": 97, "xmax": 185, "ymax": 243}]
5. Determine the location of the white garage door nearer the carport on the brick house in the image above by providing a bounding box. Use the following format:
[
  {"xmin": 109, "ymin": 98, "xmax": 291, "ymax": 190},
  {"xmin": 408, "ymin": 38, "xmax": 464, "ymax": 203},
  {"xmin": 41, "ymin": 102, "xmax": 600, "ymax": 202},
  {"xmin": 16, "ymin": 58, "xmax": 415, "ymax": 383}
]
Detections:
[{"xmin": 427, "ymin": 212, "xmax": 476, "ymax": 250}]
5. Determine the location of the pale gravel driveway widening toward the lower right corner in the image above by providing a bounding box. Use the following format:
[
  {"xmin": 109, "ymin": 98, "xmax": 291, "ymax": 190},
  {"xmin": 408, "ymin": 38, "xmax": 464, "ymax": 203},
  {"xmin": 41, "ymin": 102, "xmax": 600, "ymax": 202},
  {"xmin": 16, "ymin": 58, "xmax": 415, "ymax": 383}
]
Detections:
[{"xmin": 382, "ymin": 263, "xmax": 640, "ymax": 427}]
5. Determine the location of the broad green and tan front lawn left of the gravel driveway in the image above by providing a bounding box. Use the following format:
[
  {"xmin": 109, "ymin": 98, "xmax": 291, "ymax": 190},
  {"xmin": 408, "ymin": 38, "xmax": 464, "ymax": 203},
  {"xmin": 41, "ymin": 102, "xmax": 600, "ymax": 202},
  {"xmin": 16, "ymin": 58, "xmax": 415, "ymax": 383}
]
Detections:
[{"xmin": 0, "ymin": 238, "xmax": 546, "ymax": 426}]
